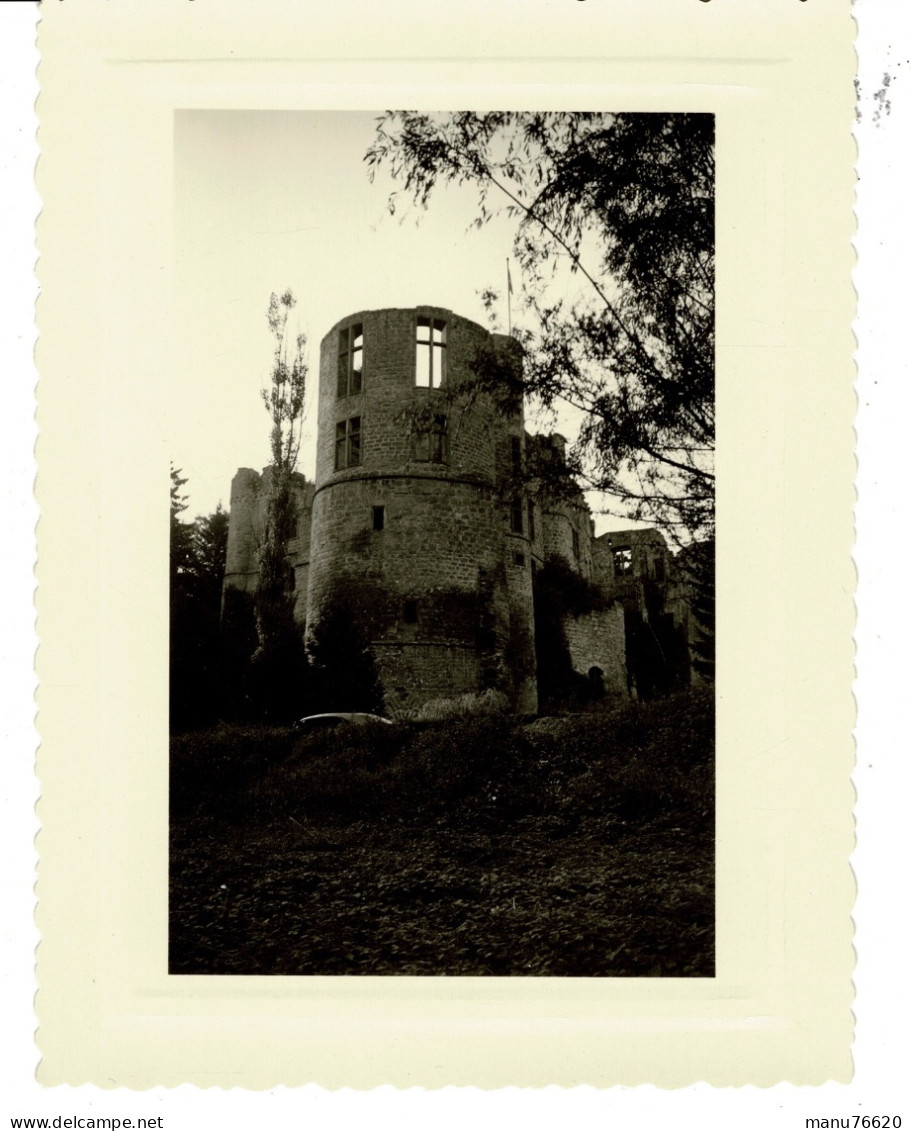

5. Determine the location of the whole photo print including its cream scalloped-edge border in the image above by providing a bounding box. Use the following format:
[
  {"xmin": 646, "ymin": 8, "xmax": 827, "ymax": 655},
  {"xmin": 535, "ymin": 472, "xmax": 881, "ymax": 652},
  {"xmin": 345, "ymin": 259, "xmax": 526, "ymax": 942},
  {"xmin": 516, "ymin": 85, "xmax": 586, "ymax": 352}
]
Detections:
[{"xmin": 23, "ymin": 0, "xmax": 860, "ymax": 1094}]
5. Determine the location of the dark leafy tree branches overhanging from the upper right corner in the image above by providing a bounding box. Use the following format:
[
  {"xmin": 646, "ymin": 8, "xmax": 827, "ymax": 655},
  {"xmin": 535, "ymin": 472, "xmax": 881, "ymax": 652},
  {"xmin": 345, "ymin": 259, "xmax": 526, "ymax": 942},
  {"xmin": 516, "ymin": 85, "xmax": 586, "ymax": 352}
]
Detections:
[{"xmin": 366, "ymin": 111, "xmax": 715, "ymax": 544}]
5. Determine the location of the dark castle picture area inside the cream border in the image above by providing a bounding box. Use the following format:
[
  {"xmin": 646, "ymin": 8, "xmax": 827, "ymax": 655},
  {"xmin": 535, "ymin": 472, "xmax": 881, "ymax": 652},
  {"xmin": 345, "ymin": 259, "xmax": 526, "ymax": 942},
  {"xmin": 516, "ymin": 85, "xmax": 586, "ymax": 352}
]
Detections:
[{"xmin": 169, "ymin": 110, "xmax": 715, "ymax": 978}]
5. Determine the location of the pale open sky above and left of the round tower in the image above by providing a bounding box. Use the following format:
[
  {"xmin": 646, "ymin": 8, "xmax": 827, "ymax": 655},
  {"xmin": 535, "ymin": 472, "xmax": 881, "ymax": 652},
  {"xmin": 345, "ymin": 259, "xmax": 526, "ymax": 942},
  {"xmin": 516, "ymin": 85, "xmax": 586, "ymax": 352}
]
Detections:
[{"xmin": 171, "ymin": 110, "xmax": 619, "ymax": 529}]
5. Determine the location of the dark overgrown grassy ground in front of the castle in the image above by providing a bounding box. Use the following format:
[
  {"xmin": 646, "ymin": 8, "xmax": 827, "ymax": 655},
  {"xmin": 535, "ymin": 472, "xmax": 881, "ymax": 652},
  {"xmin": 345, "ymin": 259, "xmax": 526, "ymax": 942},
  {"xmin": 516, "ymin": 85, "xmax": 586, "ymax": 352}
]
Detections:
[{"xmin": 170, "ymin": 693, "xmax": 714, "ymax": 977}]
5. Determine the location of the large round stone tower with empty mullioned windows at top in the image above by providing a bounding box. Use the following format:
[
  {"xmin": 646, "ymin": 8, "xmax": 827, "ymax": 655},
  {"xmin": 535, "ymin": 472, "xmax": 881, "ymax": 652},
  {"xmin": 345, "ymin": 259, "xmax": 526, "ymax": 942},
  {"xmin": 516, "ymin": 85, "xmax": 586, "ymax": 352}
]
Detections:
[{"xmin": 307, "ymin": 307, "xmax": 536, "ymax": 714}]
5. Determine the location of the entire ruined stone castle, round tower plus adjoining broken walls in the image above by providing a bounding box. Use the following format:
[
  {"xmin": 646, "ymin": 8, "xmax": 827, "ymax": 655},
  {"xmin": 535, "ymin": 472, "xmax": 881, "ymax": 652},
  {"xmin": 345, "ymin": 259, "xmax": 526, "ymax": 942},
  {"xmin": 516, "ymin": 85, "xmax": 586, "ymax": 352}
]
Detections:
[{"xmin": 225, "ymin": 307, "xmax": 688, "ymax": 716}]
